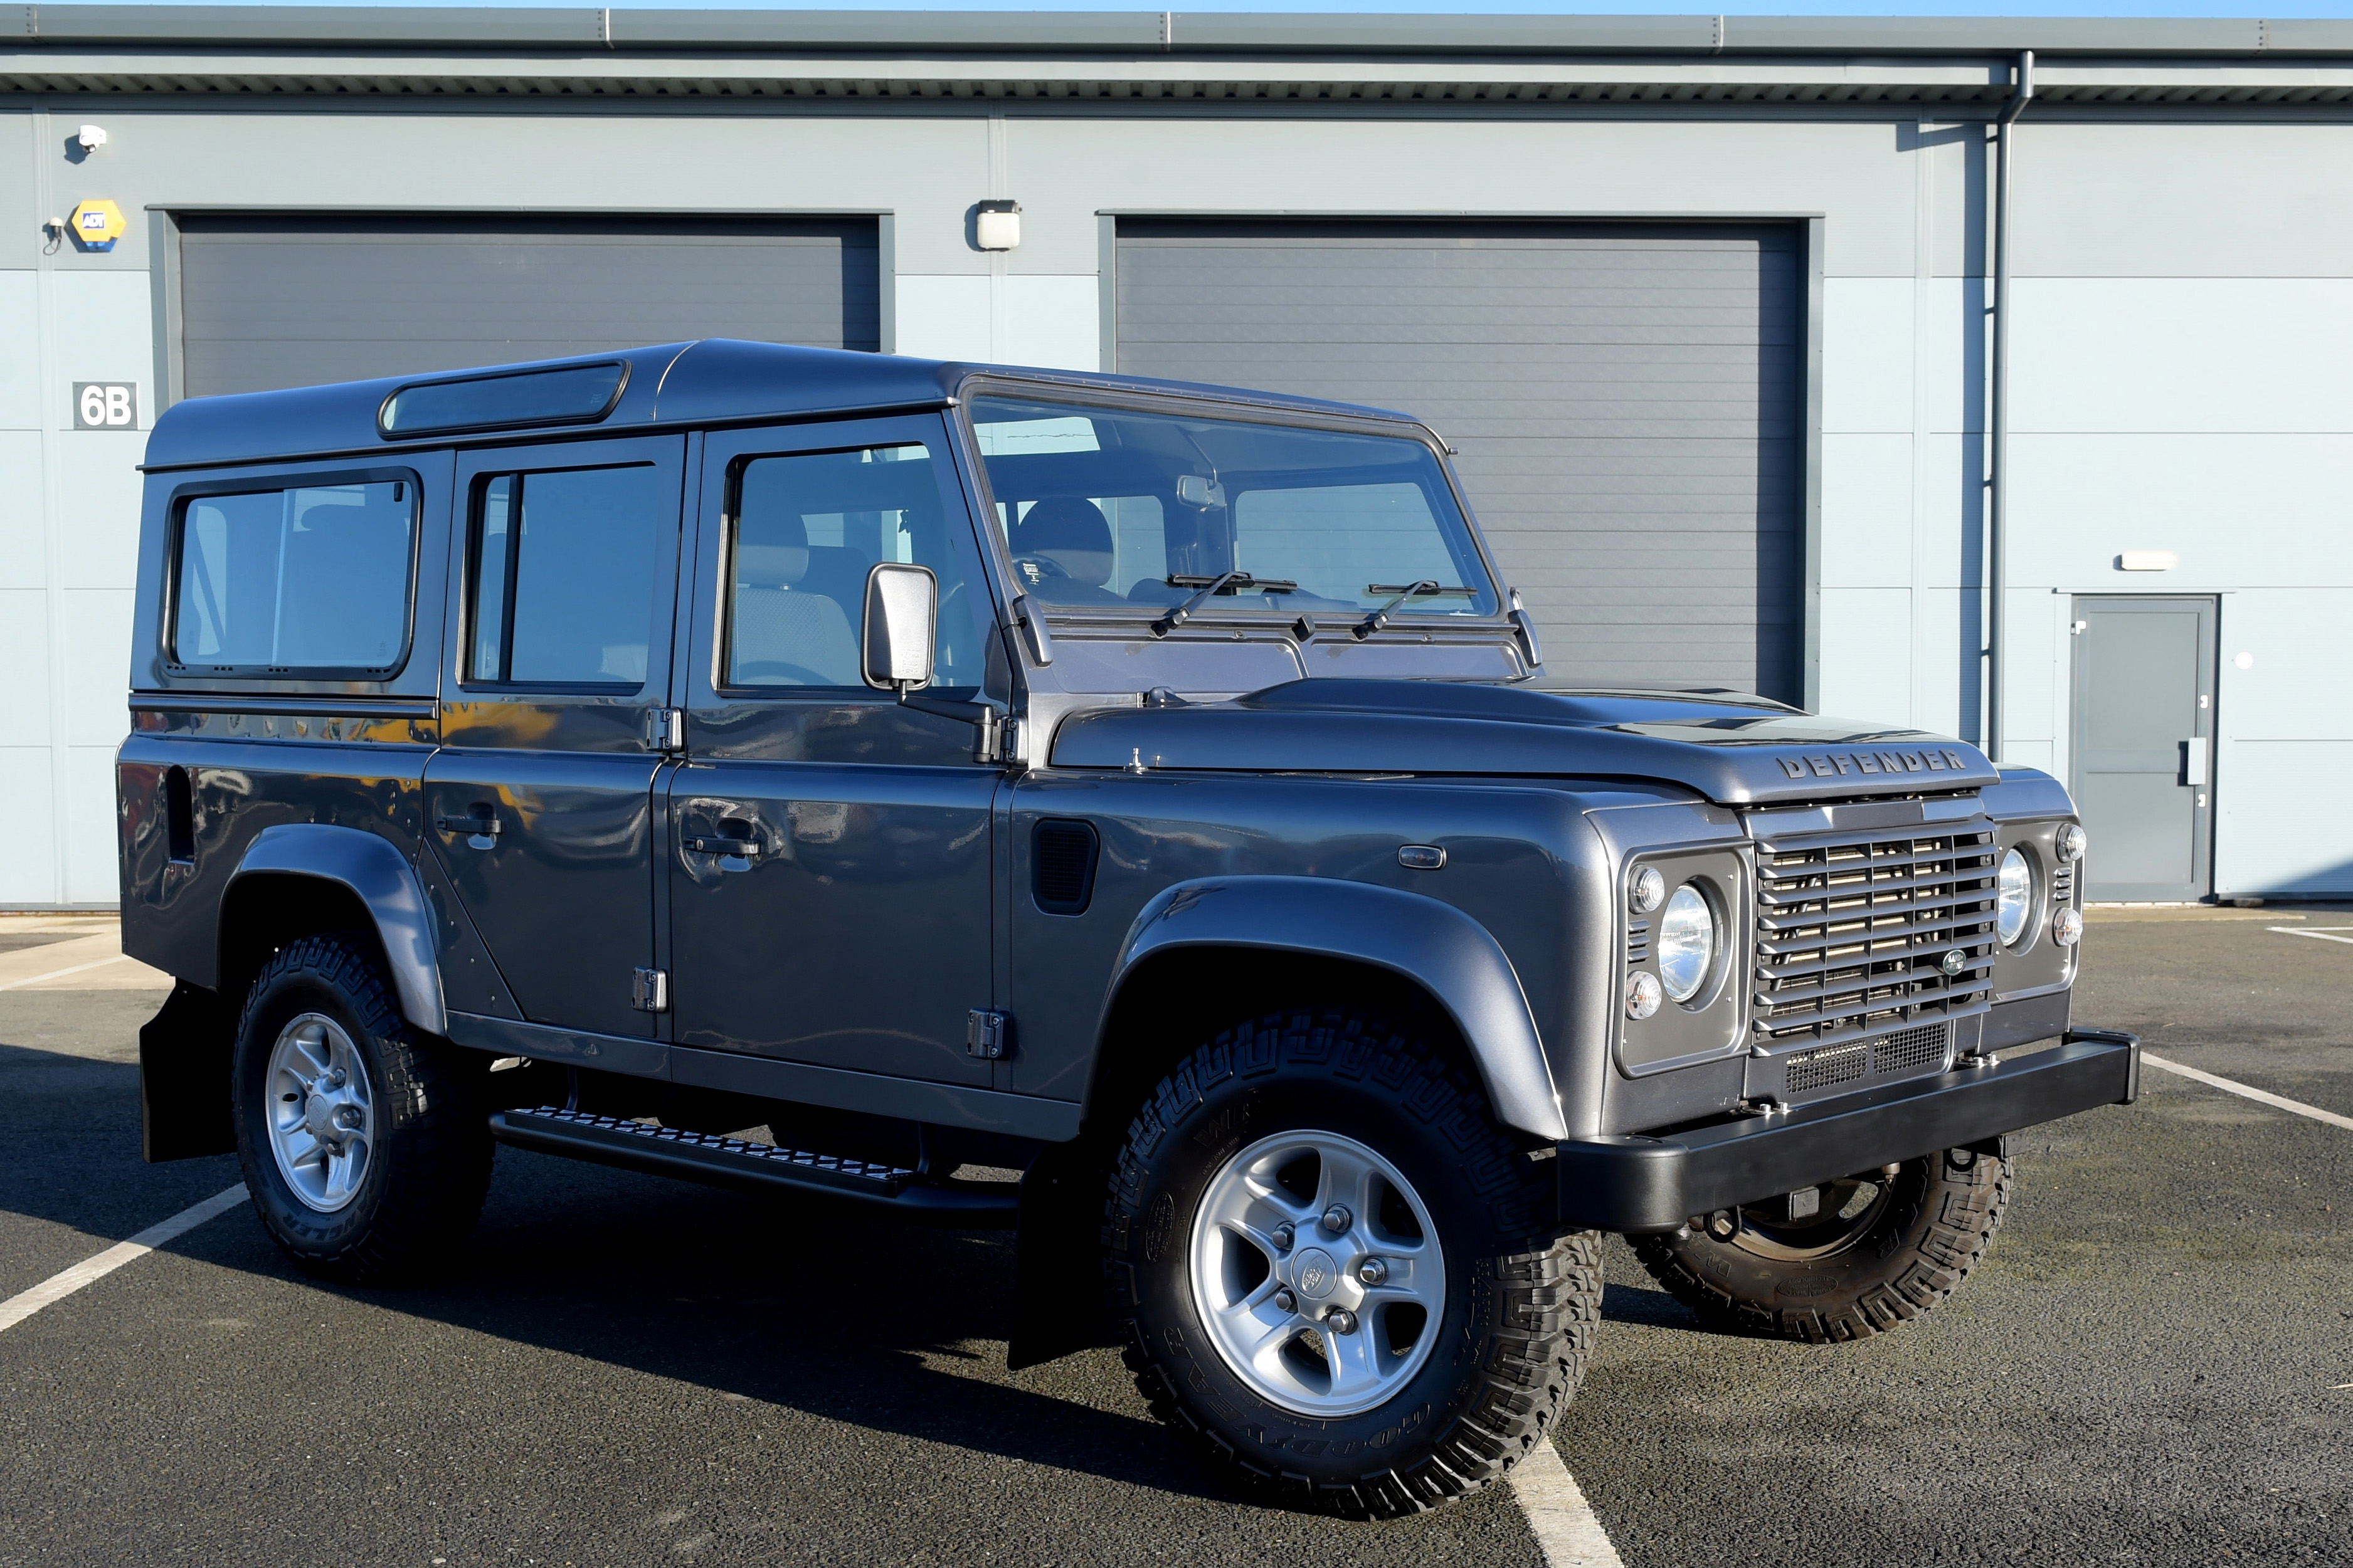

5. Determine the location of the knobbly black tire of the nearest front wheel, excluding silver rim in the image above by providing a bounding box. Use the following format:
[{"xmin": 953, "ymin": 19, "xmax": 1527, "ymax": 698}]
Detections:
[{"xmin": 1104, "ymin": 1006, "xmax": 1602, "ymax": 1518}]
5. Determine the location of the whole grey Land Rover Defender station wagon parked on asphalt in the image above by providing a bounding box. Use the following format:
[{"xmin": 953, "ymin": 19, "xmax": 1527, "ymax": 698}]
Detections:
[{"xmin": 118, "ymin": 341, "xmax": 2139, "ymax": 1517}]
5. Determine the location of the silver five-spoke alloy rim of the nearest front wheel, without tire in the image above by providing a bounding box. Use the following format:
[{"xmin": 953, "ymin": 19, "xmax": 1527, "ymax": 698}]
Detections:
[{"xmin": 1191, "ymin": 1131, "xmax": 1447, "ymax": 1418}]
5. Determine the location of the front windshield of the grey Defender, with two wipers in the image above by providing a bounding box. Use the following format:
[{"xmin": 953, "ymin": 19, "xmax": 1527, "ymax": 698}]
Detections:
[{"xmin": 972, "ymin": 397, "xmax": 1499, "ymax": 616}]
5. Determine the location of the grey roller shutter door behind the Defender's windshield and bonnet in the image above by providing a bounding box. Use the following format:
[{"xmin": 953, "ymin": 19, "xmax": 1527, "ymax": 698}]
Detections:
[{"xmin": 1118, "ymin": 219, "xmax": 1805, "ymax": 700}]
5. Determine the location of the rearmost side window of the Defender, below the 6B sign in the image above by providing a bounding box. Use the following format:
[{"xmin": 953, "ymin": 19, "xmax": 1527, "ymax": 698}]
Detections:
[{"xmin": 172, "ymin": 480, "xmax": 416, "ymax": 675}]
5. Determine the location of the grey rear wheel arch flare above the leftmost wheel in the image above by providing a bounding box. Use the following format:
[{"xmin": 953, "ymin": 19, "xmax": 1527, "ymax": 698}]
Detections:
[{"xmin": 219, "ymin": 823, "xmax": 450, "ymax": 1034}]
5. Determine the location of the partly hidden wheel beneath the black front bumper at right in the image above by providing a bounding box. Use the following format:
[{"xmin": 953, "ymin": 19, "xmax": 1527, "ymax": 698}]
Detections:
[{"xmin": 1633, "ymin": 1140, "xmax": 2016, "ymax": 1342}]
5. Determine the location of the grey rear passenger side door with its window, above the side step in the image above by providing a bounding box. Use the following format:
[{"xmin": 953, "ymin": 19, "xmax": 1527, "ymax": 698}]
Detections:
[{"xmin": 426, "ymin": 437, "xmax": 685, "ymax": 1037}]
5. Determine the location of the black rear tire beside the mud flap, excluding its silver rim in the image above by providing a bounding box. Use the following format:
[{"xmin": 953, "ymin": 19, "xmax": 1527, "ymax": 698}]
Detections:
[{"xmin": 231, "ymin": 934, "xmax": 492, "ymax": 1286}]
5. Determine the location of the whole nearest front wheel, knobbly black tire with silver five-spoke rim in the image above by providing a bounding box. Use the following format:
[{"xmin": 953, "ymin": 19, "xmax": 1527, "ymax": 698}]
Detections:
[{"xmin": 1106, "ymin": 1009, "xmax": 1600, "ymax": 1517}]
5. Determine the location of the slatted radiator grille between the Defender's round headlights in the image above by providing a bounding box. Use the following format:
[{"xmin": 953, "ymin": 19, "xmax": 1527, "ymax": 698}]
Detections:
[{"xmin": 1755, "ymin": 821, "xmax": 1996, "ymax": 1051}]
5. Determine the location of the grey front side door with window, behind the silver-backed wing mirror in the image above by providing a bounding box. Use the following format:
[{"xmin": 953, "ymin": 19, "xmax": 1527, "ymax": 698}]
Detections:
[{"xmin": 669, "ymin": 414, "xmax": 1002, "ymax": 1086}]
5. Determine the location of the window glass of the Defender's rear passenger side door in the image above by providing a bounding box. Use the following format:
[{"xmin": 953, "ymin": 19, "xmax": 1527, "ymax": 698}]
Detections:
[{"xmin": 466, "ymin": 463, "xmax": 669, "ymax": 687}]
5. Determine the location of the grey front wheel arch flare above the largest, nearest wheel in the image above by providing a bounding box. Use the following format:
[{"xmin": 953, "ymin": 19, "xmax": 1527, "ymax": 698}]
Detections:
[{"xmin": 1087, "ymin": 877, "xmax": 1570, "ymax": 1140}]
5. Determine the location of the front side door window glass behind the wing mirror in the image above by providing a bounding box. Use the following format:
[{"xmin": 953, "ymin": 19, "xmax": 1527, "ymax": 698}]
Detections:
[{"xmin": 720, "ymin": 445, "xmax": 983, "ymax": 691}]
